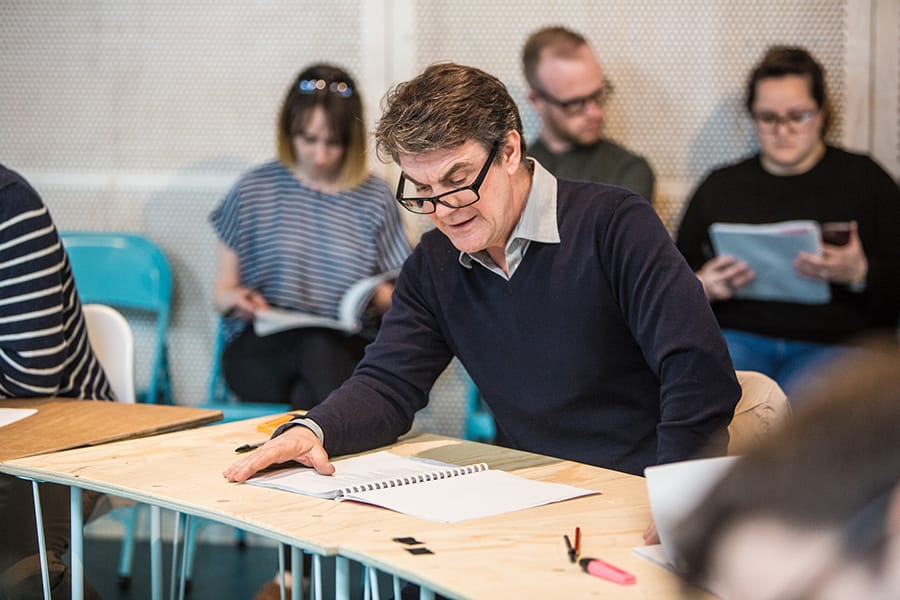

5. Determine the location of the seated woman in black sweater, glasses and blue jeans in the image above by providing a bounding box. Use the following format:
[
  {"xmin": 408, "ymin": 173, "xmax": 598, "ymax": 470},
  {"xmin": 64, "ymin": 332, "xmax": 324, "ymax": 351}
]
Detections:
[{"xmin": 677, "ymin": 47, "xmax": 900, "ymax": 396}]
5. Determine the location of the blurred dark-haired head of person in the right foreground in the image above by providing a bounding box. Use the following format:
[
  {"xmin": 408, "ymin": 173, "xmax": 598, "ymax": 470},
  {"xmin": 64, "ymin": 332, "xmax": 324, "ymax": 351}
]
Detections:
[{"xmin": 677, "ymin": 340, "xmax": 900, "ymax": 600}]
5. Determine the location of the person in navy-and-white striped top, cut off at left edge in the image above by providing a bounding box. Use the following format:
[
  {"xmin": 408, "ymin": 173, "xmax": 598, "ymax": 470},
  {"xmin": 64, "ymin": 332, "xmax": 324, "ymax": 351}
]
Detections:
[{"xmin": 0, "ymin": 165, "xmax": 114, "ymax": 599}]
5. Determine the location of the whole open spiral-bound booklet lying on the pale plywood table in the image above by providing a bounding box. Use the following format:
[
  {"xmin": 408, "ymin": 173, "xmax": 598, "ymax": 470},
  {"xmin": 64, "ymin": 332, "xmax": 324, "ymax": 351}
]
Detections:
[{"xmin": 247, "ymin": 451, "xmax": 600, "ymax": 523}]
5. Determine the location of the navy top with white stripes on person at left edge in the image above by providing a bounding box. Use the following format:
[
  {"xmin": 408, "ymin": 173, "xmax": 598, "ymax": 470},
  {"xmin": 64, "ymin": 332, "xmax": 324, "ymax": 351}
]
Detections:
[{"xmin": 0, "ymin": 166, "xmax": 113, "ymax": 400}]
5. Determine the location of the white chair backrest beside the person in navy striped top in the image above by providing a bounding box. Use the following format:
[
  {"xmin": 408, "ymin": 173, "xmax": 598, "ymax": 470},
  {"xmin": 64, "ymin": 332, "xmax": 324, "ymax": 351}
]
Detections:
[{"xmin": 84, "ymin": 304, "xmax": 135, "ymax": 404}]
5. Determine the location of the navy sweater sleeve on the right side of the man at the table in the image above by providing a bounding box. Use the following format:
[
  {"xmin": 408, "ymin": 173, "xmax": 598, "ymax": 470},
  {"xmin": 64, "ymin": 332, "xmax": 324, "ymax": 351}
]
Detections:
[{"xmin": 600, "ymin": 196, "xmax": 741, "ymax": 463}]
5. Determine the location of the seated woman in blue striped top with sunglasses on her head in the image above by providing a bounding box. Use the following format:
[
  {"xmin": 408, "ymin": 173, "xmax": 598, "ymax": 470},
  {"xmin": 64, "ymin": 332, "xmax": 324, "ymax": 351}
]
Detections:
[{"xmin": 210, "ymin": 64, "xmax": 410, "ymax": 408}]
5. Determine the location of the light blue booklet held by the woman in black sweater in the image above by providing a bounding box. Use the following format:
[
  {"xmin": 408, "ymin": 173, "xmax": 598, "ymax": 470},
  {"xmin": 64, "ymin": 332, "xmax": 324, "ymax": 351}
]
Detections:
[{"xmin": 709, "ymin": 221, "xmax": 831, "ymax": 304}]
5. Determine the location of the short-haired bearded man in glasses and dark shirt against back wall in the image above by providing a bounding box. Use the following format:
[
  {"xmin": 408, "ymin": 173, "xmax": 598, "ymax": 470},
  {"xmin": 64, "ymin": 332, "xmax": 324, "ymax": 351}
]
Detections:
[{"xmin": 522, "ymin": 27, "xmax": 653, "ymax": 202}]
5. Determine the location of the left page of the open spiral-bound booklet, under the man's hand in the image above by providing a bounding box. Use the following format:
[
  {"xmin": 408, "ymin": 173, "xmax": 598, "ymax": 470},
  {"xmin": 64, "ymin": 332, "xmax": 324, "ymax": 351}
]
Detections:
[{"xmin": 247, "ymin": 451, "xmax": 456, "ymax": 498}]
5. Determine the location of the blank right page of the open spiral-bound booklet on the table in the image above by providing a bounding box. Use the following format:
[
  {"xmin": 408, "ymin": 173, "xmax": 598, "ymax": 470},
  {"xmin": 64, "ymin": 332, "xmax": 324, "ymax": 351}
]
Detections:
[{"xmin": 350, "ymin": 470, "xmax": 600, "ymax": 523}]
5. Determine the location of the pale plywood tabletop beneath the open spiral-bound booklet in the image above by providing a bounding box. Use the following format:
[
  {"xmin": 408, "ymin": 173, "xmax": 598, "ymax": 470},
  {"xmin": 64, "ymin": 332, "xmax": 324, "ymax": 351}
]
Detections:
[{"xmin": 2, "ymin": 418, "xmax": 704, "ymax": 598}]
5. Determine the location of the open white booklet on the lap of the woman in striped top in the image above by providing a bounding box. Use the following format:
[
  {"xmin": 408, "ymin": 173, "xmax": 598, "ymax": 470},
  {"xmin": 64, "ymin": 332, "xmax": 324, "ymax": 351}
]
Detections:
[{"xmin": 253, "ymin": 269, "xmax": 399, "ymax": 336}]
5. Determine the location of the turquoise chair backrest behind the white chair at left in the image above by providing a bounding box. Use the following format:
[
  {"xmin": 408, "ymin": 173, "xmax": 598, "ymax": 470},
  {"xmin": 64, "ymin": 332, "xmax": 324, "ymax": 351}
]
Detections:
[{"xmin": 60, "ymin": 231, "xmax": 172, "ymax": 404}]
